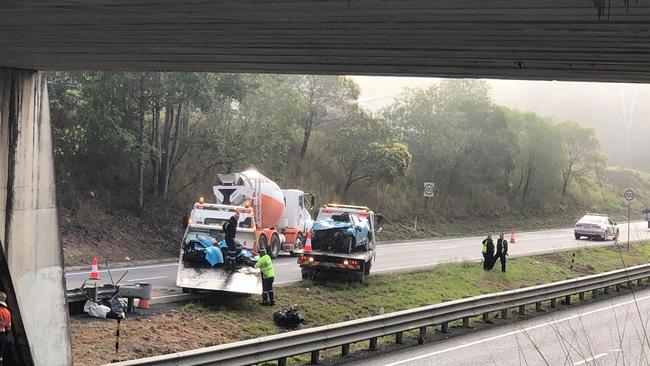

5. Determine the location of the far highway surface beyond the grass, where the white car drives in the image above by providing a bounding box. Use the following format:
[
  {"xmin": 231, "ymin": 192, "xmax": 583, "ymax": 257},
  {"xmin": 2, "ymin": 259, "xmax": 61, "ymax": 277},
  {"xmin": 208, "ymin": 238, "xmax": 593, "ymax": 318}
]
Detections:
[{"xmin": 66, "ymin": 221, "xmax": 650, "ymax": 289}]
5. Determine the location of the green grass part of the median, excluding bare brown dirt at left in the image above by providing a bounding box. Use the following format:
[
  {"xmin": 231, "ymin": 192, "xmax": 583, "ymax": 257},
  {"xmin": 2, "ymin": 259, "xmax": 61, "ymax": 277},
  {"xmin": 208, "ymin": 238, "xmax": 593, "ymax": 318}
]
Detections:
[{"xmin": 194, "ymin": 243, "xmax": 650, "ymax": 337}]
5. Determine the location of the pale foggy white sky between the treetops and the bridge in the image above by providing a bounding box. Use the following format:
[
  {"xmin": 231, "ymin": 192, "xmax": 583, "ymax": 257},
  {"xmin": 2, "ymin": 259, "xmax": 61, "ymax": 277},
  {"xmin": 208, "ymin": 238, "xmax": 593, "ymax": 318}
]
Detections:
[{"xmin": 352, "ymin": 76, "xmax": 650, "ymax": 171}]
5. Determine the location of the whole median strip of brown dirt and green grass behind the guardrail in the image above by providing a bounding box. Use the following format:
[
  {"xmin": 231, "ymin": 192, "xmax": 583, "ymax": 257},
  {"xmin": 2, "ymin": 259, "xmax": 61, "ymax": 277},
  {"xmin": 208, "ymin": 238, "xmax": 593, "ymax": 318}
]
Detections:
[{"xmin": 71, "ymin": 243, "xmax": 650, "ymax": 365}]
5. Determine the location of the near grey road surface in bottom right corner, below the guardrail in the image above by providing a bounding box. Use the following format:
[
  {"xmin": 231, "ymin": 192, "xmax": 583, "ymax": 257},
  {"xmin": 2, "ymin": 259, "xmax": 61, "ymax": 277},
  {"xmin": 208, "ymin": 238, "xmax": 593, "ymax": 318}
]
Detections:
[{"xmin": 344, "ymin": 289, "xmax": 650, "ymax": 366}]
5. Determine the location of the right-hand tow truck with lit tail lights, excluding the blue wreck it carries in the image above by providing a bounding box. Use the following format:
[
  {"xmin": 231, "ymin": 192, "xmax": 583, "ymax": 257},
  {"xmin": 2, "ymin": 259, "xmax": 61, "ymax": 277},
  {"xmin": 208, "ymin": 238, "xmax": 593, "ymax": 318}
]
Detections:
[{"xmin": 295, "ymin": 203, "xmax": 381, "ymax": 283}]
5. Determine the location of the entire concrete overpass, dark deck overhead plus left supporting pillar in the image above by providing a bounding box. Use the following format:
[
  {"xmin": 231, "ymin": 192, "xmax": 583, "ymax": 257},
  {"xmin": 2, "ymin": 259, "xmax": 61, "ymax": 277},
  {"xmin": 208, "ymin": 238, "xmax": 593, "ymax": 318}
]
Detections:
[{"xmin": 0, "ymin": 0, "xmax": 650, "ymax": 365}]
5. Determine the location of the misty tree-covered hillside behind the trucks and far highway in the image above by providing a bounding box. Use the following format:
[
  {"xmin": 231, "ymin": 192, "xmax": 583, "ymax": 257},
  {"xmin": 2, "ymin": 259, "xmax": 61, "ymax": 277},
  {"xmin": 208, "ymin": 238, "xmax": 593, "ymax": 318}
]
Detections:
[{"xmin": 48, "ymin": 72, "xmax": 650, "ymax": 265}]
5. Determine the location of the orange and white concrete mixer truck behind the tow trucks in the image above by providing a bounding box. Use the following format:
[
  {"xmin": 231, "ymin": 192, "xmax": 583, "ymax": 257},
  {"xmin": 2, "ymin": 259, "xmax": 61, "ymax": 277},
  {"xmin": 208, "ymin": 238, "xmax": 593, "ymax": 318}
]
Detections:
[{"xmin": 213, "ymin": 170, "xmax": 314, "ymax": 258}]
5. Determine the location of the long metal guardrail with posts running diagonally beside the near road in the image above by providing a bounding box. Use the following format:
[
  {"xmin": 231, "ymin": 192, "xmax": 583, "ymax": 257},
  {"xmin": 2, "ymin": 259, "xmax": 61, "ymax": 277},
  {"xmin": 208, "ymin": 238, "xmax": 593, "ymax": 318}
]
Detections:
[{"xmin": 111, "ymin": 264, "xmax": 650, "ymax": 366}]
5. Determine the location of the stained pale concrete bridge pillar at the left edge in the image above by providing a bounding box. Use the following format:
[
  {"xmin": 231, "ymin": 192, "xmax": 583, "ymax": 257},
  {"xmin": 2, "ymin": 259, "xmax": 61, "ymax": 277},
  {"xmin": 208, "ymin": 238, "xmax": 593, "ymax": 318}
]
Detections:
[{"xmin": 0, "ymin": 68, "xmax": 72, "ymax": 366}]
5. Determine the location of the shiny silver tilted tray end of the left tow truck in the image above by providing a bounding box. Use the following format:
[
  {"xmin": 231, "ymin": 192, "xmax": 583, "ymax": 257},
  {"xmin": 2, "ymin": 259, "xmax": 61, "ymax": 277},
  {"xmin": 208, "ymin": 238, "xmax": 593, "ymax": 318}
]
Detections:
[{"xmin": 176, "ymin": 260, "xmax": 262, "ymax": 295}]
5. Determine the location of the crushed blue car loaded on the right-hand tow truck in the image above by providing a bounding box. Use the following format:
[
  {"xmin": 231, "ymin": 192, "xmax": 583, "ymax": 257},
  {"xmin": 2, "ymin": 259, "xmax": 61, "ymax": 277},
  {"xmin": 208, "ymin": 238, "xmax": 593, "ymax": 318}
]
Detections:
[{"xmin": 312, "ymin": 212, "xmax": 370, "ymax": 253}]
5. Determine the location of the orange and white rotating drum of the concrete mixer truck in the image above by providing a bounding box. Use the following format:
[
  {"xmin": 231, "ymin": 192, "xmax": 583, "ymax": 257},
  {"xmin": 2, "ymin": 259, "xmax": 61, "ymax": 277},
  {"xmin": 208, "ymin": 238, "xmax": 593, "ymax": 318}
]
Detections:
[{"xmin": 238, "ymin": 170, "xmax": 285, "ymax": 228}]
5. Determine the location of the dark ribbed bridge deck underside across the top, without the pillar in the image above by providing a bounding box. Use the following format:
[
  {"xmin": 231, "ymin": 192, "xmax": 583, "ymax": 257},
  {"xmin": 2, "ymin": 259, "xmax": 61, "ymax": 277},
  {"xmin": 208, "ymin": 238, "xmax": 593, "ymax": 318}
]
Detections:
[{"xmin": 0, "ymin": 0, "xmax": 650, "ymax": 82}]
